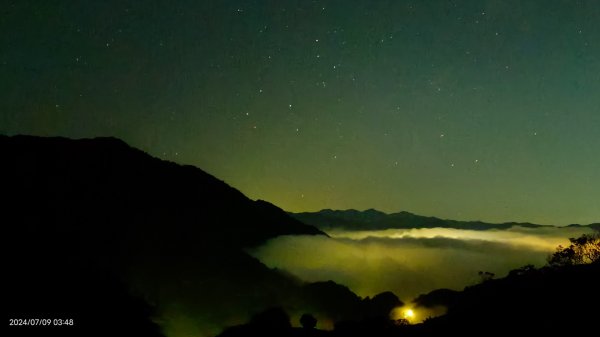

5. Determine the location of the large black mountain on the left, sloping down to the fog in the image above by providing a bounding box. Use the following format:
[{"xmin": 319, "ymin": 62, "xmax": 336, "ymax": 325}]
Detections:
[{"xmin": 0, "ymin": 136, "xmax": 399, "ymax": 335}]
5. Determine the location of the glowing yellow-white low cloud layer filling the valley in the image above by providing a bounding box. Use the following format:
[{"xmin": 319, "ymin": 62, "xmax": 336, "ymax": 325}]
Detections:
[{"xmin": 251, "ymin": 227, "xmax": 591, "ymax": 301}]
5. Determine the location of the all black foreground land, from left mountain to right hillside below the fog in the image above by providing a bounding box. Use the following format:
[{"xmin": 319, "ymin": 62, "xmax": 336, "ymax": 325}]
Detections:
[{"xmin": 0, "ymin": 136, "xmax": 600, "ymax": 337}]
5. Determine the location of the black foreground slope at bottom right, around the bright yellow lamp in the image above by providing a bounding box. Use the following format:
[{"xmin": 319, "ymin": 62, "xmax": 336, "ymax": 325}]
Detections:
[{"xmin": 213, "ymin": 261, "xmax": 600, "ymax": 337}]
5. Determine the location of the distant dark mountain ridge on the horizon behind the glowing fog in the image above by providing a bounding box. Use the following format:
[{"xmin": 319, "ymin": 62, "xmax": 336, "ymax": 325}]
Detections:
[{"xmin": 289, "ymin": 209, "xmax": 600, "ymax": 231}]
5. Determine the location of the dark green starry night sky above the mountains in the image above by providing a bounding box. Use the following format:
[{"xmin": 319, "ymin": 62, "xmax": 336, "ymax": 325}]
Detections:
[{"xmin": 0, "ymin": 0, "xmax": 600, "ymax": 225}]
